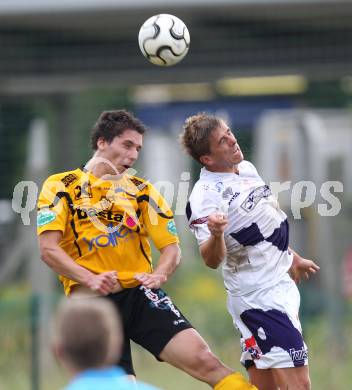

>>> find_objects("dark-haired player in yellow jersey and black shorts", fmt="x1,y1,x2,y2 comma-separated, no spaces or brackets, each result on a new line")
37,110,255,390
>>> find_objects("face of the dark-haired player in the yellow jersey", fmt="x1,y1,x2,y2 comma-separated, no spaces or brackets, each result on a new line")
98,129,143,173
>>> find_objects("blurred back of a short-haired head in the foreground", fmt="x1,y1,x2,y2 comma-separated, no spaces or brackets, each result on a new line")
52,298,122,374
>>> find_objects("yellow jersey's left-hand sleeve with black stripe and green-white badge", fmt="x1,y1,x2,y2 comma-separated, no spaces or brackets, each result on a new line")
37,176,69,235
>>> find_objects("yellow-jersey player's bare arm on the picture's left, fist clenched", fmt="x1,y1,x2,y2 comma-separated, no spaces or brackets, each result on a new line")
39,230,117,295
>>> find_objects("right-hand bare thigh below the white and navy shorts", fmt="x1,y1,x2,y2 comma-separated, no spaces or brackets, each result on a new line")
272,366,310,390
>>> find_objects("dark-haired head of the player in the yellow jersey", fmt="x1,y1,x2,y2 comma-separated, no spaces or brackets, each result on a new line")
91,110,146,172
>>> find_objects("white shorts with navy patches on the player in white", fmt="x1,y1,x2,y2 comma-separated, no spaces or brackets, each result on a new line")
227,274,308,369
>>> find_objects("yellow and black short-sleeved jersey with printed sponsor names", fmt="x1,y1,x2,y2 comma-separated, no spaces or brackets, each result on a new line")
37,168,178,295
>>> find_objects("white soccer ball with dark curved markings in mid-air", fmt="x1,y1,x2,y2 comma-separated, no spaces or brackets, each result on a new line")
138,14,190,66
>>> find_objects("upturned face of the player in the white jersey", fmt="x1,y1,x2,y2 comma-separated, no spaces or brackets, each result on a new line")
204,121,243,172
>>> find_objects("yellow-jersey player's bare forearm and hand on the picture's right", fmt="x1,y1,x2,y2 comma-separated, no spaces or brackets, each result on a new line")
135,243,181,288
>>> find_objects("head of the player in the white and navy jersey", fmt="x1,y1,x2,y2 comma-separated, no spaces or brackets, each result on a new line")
180,113,243,172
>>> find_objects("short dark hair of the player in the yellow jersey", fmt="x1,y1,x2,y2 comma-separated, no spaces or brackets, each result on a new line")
90,110,146,150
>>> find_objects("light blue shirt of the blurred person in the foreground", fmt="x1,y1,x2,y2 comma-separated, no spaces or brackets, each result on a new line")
64,367,158,390
